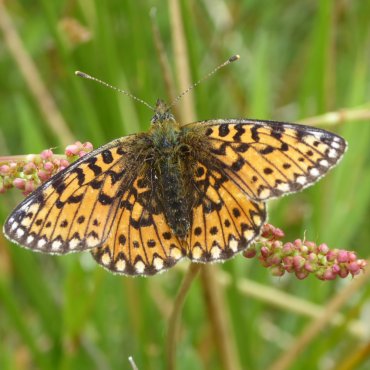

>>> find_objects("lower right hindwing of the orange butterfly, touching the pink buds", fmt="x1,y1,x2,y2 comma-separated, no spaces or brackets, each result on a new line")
187,160,266,262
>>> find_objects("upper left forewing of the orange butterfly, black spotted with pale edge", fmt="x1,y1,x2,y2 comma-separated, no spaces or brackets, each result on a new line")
4,135,135,254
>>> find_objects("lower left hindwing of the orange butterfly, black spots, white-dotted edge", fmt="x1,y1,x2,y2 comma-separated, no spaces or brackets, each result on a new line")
92,168,185,275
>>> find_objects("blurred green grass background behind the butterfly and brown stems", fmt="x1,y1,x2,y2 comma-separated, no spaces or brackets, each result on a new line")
0,0,370,370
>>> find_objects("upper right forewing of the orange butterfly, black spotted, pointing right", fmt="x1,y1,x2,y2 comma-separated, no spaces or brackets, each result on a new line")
188,119,347,200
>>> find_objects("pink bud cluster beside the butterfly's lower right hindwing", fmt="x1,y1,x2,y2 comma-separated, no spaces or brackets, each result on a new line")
244,224,366,280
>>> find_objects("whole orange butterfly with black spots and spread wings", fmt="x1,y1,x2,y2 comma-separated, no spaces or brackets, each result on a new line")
4,60,347,275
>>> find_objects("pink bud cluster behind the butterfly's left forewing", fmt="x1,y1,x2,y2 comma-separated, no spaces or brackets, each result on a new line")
0,141,93,195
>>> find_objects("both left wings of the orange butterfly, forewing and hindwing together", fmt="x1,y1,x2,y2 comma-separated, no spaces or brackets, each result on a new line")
4,135,184,275
